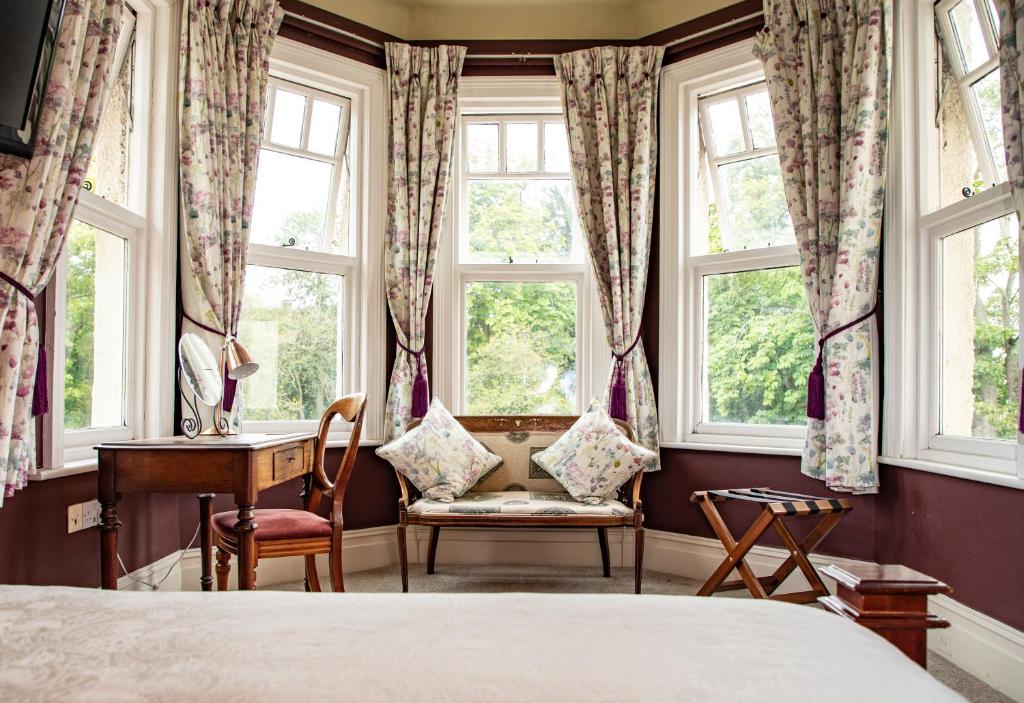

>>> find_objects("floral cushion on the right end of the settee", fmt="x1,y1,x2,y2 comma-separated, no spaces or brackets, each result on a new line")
534,398,657,504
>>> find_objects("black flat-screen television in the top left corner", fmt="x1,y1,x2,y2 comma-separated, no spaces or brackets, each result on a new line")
0,0,65,158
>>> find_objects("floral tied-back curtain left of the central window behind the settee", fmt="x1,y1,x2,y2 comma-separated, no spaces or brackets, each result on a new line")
384,43,466,440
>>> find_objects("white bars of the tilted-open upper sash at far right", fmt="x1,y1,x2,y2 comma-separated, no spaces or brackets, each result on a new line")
929,0,999,186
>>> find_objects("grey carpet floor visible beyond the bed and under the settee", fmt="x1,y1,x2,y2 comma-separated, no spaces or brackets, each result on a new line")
266,564,1013,703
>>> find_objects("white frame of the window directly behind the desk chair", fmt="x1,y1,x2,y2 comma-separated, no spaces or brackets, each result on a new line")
243,37,387,446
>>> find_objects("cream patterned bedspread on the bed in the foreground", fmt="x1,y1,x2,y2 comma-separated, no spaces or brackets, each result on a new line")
0,586,963,703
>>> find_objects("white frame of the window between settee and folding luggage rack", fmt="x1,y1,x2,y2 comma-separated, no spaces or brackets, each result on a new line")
658,40,809,455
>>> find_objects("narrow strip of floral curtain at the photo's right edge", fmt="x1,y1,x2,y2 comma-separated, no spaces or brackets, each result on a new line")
995,0,1024,432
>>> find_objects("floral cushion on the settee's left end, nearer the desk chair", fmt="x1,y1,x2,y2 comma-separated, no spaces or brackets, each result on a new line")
377,398,502,502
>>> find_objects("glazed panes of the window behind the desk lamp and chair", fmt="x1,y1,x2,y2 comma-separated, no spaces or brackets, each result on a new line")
239,78,355,423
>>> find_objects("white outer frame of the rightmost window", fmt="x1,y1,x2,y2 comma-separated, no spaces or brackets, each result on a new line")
879,0,1024,488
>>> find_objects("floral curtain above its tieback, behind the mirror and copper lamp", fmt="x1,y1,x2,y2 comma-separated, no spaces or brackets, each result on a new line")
178,0,285,422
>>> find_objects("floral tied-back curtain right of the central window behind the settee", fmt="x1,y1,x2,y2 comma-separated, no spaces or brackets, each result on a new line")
555,46,665,462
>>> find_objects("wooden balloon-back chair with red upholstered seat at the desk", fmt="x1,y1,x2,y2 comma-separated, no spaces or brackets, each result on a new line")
213,393,367,592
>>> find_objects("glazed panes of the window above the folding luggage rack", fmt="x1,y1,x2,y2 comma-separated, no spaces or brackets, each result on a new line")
690,80,815,437
